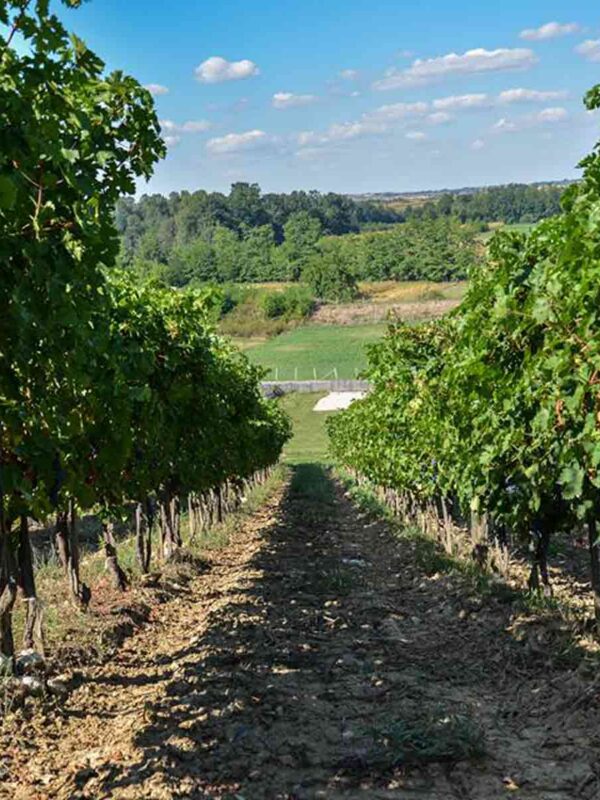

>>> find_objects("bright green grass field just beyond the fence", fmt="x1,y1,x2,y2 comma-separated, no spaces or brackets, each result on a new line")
246,323,387,380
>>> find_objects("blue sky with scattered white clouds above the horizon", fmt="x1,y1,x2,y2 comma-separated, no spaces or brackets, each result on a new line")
59,0,600,192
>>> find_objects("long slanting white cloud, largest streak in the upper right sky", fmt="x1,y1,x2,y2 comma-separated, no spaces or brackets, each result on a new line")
373,47,538,91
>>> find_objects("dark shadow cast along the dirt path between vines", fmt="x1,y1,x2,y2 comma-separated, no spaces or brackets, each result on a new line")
55,464,591,800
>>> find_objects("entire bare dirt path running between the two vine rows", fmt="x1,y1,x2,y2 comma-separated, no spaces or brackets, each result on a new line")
0,465,600,800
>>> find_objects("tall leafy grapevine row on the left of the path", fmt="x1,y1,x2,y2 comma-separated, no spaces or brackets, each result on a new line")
0,0,290,674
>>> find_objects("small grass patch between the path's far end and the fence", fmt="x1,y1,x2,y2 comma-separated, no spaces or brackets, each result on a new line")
281,392,335,464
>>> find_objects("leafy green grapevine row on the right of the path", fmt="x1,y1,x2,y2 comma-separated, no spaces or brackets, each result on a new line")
329,86,600,622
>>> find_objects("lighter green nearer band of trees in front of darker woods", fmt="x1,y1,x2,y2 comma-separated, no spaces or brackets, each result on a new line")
127,217,483,292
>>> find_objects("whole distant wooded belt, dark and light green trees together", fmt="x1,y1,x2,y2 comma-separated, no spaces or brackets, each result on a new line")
116,183,548,287
